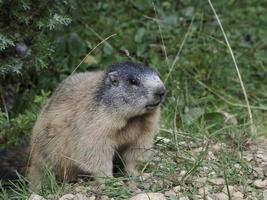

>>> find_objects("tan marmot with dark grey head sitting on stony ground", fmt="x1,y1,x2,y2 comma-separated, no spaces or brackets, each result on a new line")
0,61,166,190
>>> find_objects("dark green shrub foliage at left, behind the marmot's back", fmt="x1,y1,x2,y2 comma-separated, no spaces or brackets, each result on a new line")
0,0,72,146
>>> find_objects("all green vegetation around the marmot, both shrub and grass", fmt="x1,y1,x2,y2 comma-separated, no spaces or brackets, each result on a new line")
0,0,267,199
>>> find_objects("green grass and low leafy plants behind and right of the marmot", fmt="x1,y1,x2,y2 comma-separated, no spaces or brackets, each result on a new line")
0,0,267,199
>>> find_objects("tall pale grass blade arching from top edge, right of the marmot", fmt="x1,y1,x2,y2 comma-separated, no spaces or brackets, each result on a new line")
208,0,256,134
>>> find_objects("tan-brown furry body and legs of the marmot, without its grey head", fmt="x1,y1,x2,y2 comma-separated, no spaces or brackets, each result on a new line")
28,71,160,189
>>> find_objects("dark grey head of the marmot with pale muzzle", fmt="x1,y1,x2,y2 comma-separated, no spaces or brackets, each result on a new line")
97,62,166,117
